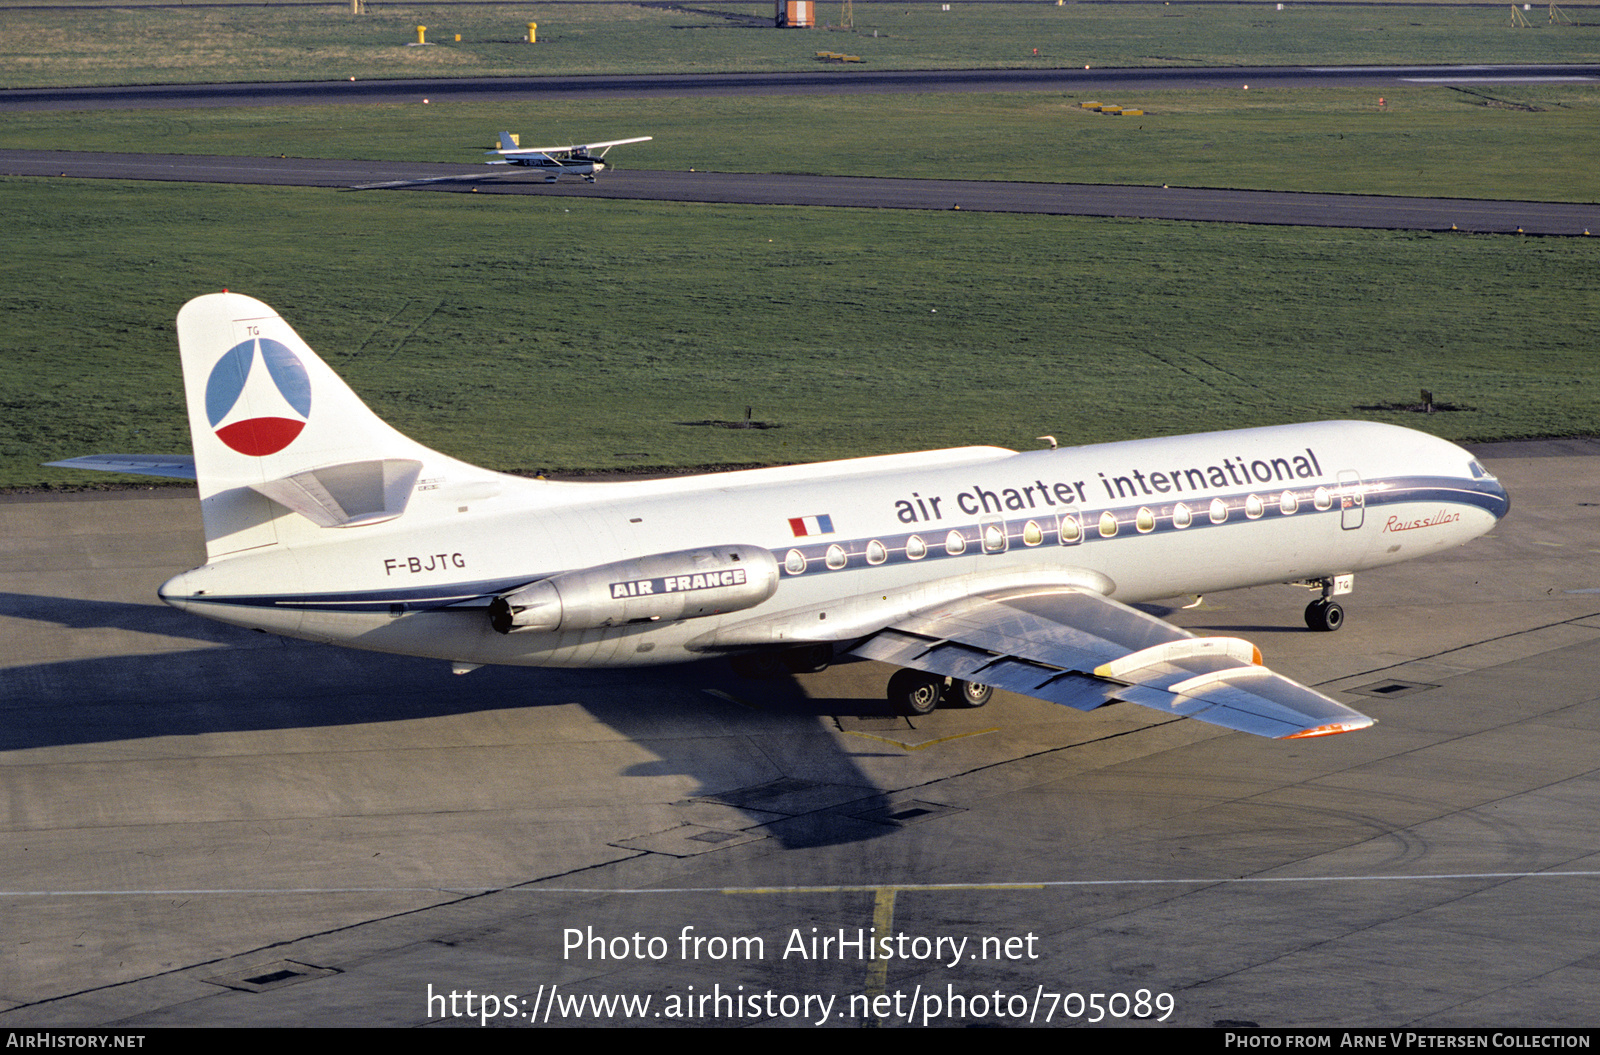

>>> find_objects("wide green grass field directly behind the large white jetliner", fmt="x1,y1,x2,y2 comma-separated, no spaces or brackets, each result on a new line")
0,179,1600,485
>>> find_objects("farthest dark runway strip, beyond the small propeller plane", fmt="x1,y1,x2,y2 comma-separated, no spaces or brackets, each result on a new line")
0,62,1600,112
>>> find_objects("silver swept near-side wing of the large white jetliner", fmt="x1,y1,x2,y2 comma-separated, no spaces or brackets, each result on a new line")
851,586,1373,738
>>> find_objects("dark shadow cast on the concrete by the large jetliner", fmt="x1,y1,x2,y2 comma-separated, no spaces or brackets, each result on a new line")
0,594,894,847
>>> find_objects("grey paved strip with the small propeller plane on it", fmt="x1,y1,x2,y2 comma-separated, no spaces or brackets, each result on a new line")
0,150,1600,235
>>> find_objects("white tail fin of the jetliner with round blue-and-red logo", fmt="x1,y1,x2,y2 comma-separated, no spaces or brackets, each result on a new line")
178,293,493,560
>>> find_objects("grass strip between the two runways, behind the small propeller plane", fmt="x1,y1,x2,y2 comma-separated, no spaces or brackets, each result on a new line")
0,85,1600,202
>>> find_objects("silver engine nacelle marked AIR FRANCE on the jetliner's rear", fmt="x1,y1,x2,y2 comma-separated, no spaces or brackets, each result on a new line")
490,546,778,634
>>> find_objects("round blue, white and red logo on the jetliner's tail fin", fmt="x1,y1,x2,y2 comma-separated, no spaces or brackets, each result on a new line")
205,338,310,458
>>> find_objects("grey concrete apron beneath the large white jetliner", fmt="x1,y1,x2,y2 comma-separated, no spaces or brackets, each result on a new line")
0,440,1600,1029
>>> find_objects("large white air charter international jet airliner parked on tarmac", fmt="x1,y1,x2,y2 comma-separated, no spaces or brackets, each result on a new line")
53,293,1509,736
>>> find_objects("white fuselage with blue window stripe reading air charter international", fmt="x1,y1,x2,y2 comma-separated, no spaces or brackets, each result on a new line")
162,421,1509,666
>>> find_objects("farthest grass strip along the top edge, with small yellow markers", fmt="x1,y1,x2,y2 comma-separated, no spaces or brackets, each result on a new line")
0,2,1600,88
